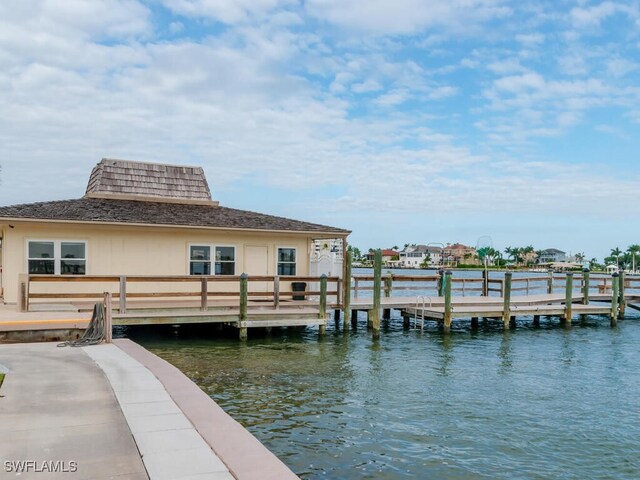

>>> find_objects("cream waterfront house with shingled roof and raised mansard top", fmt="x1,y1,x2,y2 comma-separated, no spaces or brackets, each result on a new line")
0,158,350,303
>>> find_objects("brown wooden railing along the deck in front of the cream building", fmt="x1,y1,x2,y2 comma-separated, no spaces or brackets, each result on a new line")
20,275,341,313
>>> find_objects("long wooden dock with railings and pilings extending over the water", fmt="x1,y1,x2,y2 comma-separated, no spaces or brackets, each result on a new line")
6,251,640,339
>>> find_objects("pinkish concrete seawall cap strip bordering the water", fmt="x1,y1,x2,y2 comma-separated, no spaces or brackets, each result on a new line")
113,339,298,480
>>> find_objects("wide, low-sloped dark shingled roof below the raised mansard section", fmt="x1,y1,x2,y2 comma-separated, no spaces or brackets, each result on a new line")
0,197,351,237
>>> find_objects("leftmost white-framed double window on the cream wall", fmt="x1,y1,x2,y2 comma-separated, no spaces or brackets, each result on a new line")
27,240,87,275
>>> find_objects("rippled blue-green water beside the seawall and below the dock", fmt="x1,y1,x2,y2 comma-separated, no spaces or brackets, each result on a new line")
128,270,640,479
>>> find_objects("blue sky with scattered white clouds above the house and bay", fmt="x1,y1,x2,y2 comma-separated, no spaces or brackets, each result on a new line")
0,0,640,258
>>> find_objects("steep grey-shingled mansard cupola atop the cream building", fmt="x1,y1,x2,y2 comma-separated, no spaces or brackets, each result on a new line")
85,158,216,205
